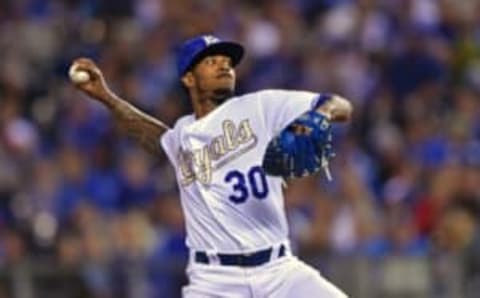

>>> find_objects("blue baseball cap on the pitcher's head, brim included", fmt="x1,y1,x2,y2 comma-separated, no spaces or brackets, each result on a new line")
177,35,244,77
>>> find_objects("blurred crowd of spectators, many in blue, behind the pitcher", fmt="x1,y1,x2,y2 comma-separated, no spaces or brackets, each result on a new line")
0,0,480,297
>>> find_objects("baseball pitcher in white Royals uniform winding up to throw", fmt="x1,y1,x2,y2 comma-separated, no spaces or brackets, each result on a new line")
70,35,352,298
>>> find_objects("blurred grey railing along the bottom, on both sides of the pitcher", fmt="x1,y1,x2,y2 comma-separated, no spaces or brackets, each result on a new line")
0,256,464,298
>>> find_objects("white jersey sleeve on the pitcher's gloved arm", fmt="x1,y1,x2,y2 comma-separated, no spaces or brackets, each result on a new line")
259,90,318,137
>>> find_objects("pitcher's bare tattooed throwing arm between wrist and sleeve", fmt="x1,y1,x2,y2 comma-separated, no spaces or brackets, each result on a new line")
103,94,168,155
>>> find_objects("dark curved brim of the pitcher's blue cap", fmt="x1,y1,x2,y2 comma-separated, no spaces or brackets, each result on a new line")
183,41,245,74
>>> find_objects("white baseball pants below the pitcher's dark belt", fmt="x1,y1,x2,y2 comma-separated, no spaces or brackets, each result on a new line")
183,255,347,298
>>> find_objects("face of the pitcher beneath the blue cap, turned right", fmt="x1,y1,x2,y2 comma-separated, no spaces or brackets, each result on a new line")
187,55,235,101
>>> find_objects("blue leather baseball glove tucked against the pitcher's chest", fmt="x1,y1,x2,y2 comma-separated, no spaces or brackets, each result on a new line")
262,110,335,180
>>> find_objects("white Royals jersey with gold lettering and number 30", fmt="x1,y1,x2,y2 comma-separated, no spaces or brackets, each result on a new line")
161,90,317,253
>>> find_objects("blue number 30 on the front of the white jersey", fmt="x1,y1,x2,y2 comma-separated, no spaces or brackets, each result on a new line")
224,166,268,204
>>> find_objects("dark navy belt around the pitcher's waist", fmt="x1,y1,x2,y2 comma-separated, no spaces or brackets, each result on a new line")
195,244,285,267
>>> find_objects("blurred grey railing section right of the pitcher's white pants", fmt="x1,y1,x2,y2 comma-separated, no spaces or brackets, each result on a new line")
307,256,465,298
